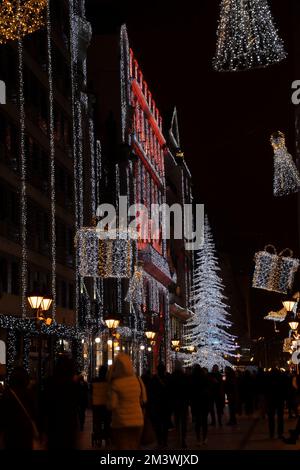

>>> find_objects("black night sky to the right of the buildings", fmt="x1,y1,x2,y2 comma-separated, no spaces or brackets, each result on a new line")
87,0,300,344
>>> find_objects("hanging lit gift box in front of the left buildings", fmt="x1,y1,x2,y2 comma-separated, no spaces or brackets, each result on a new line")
75,227,137,278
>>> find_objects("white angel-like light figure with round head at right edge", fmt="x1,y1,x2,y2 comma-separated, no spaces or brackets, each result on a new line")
270,131,300,196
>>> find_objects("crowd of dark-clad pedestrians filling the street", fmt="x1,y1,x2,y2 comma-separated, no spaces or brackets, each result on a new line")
0,353,300,450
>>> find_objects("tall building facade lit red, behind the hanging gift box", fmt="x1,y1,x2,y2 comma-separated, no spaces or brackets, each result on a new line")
89,26,172,372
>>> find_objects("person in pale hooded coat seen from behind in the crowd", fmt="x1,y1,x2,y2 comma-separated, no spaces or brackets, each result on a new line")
108,353,147,450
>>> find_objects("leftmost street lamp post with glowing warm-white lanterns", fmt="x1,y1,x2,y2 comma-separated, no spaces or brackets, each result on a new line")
27,293,53,390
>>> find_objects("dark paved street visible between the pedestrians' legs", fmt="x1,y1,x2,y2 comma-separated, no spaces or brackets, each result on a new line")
78,410,300,450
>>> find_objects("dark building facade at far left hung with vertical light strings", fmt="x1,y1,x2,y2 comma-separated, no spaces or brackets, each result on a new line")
0,0,97,375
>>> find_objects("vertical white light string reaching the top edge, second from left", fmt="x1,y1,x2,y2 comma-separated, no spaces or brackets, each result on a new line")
47,1,56,319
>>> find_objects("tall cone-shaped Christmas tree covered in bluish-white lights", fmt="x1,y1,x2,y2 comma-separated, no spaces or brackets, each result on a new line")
186,217,236,369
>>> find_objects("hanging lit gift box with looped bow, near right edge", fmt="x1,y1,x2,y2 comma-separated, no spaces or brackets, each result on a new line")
252,245,299,294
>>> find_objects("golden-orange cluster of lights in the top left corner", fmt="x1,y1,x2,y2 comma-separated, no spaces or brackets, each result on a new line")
0,0,48,44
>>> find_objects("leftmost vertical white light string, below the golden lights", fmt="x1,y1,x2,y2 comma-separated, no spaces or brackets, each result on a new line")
18,39,28,317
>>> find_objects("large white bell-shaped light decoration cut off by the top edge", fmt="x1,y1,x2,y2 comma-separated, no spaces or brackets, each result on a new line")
213,0,287,72
